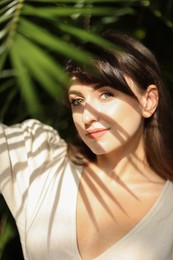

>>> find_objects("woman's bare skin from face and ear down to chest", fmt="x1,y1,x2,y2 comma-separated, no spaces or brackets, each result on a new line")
69,78,165,260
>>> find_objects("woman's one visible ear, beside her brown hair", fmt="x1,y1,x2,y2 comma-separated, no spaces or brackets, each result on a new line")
142,85,159,118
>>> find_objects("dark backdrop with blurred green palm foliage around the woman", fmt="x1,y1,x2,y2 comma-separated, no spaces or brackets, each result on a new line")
0,0,173,260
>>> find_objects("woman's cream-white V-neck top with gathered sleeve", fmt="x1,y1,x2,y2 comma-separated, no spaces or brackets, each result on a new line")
0,120,173,260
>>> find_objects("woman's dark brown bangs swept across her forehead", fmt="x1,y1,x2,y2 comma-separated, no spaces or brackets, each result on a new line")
66,44,135,97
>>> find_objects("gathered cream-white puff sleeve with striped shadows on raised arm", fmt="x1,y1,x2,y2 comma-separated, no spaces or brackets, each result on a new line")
0,120,67,219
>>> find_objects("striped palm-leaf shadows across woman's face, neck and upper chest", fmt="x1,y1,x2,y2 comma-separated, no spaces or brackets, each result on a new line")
71,97,159,230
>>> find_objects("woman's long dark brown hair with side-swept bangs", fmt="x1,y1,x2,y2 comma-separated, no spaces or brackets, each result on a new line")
66,32,173,180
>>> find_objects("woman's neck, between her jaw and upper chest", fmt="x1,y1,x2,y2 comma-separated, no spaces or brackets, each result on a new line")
88,135,162,182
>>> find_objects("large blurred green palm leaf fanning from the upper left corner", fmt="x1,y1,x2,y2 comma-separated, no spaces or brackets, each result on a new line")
0,0,172,119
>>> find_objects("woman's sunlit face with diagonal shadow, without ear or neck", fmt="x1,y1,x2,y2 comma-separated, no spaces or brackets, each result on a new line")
69,79,143,155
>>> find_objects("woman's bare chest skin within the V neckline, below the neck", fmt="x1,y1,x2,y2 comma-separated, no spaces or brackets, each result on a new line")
77,179,168,260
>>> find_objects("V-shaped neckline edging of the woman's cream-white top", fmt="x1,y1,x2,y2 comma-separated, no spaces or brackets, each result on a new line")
74,167,170,260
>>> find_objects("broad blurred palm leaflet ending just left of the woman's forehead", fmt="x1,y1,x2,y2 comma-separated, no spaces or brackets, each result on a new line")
13,36,67,100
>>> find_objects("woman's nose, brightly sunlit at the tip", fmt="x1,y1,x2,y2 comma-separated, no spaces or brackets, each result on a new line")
82,103,98,124
